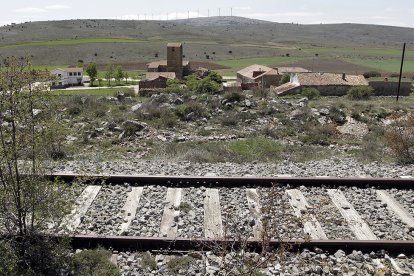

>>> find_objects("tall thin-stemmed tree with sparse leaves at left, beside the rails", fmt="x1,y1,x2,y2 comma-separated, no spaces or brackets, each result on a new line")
0,57,68,275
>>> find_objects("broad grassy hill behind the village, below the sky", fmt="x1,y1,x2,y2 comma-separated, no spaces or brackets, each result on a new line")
0,17,414,72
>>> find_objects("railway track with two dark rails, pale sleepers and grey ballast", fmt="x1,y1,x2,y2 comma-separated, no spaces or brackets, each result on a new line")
50,174,414,275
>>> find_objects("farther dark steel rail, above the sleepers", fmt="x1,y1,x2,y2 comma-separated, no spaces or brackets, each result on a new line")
45,174,414,189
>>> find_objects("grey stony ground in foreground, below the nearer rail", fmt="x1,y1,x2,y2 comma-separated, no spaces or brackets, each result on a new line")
110,248,414,276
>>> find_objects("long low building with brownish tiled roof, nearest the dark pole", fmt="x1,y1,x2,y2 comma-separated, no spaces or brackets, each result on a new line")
272,73,368,96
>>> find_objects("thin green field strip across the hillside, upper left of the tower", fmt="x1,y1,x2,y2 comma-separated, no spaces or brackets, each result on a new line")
0,38,145,48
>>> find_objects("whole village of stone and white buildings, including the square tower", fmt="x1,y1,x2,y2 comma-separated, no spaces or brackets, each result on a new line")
51,43,411,96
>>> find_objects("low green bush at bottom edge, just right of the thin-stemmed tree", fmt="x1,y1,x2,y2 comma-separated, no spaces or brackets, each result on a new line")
72,248,121,276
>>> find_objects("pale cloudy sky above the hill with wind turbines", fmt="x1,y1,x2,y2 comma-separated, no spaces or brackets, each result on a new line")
0,0,414,28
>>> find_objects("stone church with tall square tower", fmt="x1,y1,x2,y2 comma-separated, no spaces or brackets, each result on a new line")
147,43,190,79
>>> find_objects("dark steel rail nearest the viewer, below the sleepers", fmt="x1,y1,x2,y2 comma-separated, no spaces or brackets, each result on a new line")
71,235,414,255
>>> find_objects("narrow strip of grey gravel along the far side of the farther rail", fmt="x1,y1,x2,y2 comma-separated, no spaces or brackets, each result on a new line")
49,158,414,177
